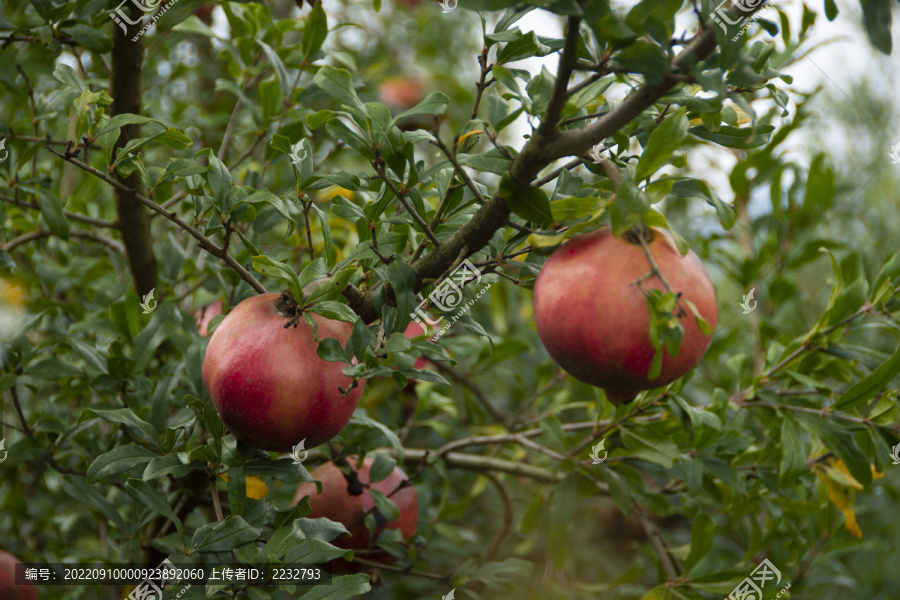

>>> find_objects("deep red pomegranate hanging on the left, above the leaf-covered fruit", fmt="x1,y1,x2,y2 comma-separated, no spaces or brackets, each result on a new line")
203,291,365,452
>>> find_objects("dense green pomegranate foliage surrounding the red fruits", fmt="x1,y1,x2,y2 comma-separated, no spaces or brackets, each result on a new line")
0,0,900,600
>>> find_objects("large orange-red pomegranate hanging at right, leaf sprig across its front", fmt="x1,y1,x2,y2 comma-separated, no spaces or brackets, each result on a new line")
534,228,718,405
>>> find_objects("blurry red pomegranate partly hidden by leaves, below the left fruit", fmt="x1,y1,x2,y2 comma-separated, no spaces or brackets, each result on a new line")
294,456,419,550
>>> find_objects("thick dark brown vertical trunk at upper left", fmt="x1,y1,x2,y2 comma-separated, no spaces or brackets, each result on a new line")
109,6,157,295
